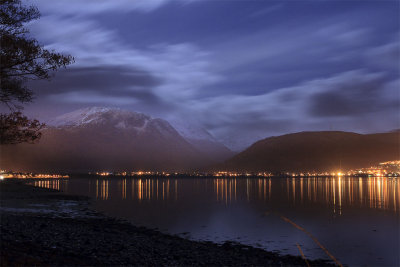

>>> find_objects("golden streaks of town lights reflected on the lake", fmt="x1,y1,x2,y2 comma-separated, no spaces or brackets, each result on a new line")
34,177,400,214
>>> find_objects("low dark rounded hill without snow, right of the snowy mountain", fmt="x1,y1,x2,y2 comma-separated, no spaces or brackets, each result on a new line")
217,131,400,172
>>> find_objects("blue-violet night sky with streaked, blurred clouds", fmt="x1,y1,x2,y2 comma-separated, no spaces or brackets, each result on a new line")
25,0,400,151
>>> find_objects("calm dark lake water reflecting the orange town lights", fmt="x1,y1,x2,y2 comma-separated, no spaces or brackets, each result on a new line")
35,177,400,266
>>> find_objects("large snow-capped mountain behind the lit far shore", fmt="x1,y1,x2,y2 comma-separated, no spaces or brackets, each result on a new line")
0,107,231,172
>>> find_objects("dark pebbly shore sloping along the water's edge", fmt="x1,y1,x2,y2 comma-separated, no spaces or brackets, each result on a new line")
0,180,332,266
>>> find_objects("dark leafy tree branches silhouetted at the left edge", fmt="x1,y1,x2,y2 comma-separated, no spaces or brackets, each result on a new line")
0,0,74,144
